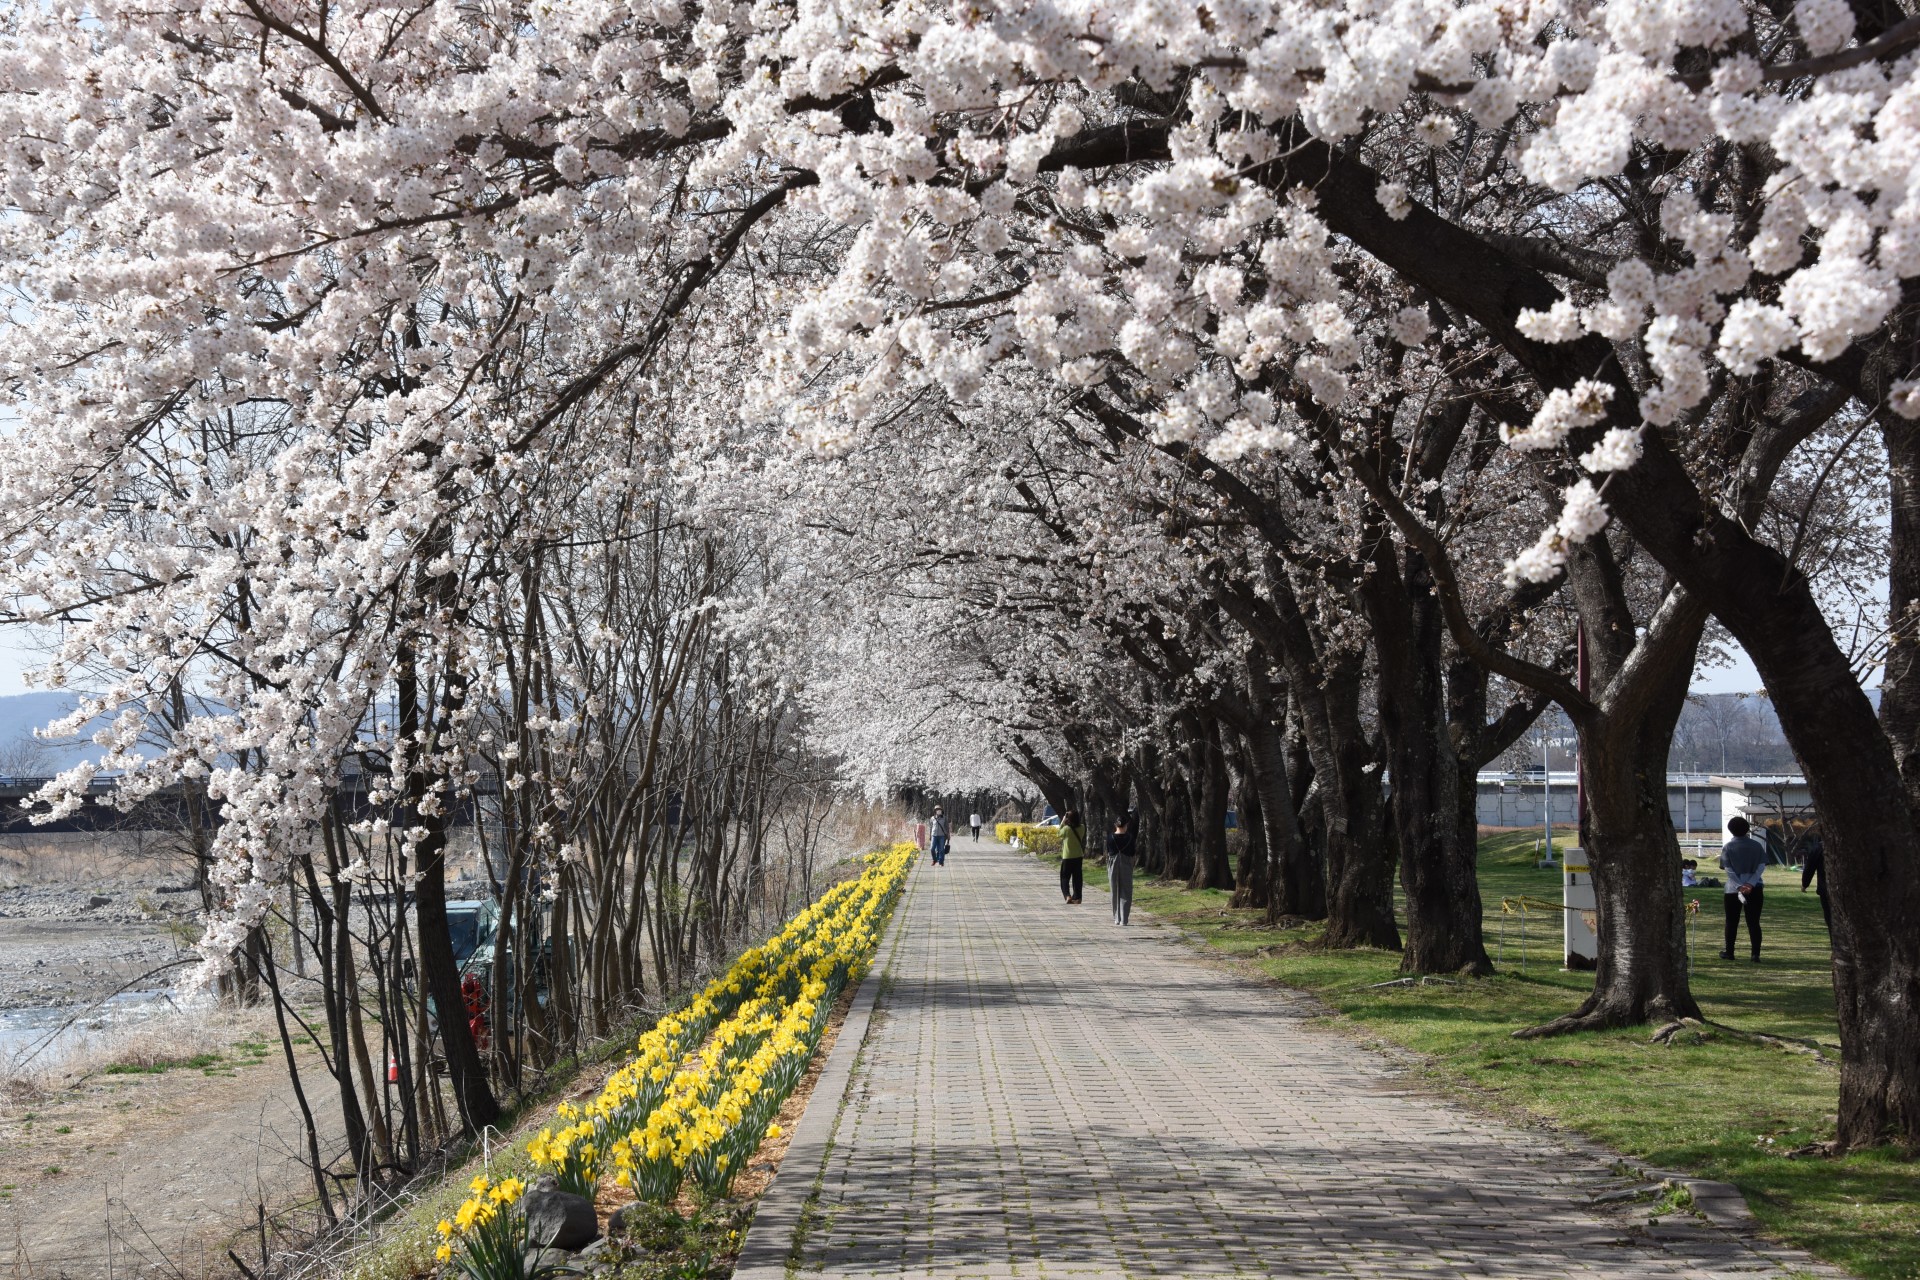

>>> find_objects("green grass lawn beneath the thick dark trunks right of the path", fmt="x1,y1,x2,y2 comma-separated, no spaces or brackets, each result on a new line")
1036,833,1920,1280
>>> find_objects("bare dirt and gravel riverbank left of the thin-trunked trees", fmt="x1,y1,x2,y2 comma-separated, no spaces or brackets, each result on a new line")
0,837,344,1280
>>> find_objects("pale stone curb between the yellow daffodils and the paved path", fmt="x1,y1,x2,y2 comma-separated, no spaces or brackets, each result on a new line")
733,862,920,1280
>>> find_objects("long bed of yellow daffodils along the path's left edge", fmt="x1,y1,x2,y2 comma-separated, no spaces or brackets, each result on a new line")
440,842,918,1280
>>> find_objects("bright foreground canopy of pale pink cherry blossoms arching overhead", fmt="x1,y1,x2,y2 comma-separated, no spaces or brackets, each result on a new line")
0,0,1920,969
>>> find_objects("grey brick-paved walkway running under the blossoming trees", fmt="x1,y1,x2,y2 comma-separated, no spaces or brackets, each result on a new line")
756,839,1837,1278
